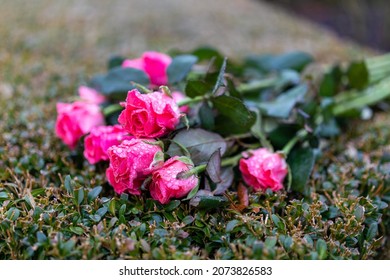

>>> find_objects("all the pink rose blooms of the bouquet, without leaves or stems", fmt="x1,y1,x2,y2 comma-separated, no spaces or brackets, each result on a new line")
55,52,288,204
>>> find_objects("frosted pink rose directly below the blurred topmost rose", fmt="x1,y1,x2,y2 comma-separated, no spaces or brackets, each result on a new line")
118,89,180,138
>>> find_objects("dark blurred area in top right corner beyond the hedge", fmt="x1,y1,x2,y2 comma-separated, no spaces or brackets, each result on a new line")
266,0,390,51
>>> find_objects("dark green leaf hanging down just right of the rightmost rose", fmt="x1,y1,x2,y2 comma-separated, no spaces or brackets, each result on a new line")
287,148,315,196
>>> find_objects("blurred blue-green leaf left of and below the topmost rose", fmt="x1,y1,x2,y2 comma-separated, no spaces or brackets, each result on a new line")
91,67,150,100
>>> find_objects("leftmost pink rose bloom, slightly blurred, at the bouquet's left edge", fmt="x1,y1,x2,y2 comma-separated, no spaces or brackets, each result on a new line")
55,101,104,149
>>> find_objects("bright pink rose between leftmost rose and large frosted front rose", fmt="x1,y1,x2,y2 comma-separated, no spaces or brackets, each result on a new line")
84,125,133,164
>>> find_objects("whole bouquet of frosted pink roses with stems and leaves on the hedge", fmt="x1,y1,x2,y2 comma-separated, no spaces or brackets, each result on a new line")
55,48,390,207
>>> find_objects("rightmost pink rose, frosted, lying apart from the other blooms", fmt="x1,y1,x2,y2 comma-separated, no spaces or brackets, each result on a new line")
239,148,288,191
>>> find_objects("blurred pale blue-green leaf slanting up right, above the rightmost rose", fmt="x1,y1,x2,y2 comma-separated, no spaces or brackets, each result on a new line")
259,84,308,118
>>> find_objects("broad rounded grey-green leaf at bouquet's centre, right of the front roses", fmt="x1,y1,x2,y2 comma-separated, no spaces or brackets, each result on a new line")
167,128,227,165
